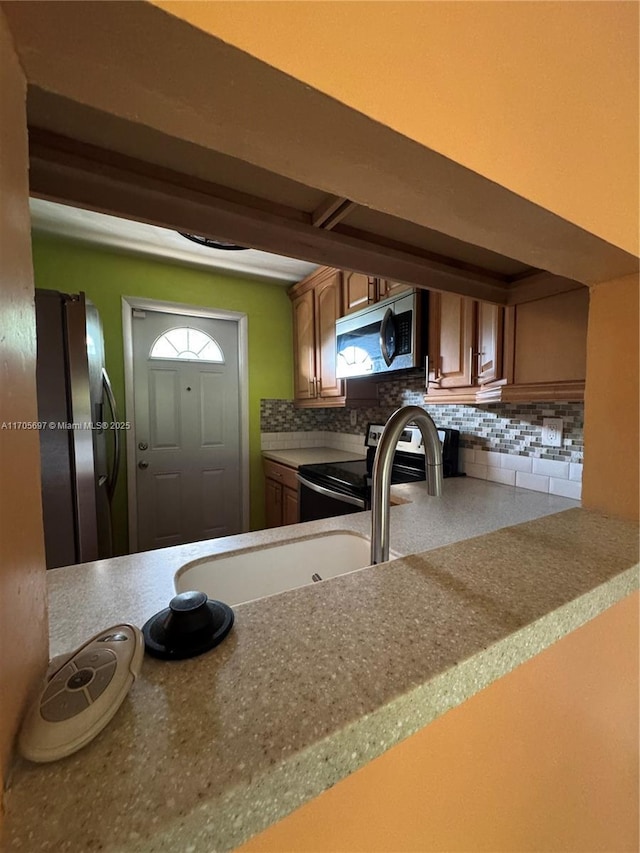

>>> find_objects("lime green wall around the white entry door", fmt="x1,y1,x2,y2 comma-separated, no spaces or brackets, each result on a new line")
33,234,293,554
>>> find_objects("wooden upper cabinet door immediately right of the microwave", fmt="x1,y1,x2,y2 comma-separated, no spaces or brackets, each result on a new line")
429,293,475,388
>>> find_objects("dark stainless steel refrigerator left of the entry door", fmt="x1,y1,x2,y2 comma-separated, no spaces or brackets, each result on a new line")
36,290,120,569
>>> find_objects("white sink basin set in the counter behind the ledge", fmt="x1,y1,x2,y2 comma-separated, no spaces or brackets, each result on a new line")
175,531,395,605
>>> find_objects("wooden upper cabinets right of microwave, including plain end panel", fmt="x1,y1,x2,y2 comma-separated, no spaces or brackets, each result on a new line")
425,282,589,403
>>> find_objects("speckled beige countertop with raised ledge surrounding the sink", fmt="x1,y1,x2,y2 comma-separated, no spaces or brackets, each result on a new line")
6,480,638,853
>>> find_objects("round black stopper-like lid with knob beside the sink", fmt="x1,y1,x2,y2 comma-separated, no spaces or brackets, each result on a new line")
142,590,234,660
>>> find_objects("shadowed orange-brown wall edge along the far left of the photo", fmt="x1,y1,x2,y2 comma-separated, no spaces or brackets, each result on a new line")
0,11,48,792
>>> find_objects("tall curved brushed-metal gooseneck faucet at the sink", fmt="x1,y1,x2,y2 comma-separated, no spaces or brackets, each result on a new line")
371,406,442,565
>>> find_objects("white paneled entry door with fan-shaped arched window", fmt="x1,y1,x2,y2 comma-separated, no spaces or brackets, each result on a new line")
132,310,242,551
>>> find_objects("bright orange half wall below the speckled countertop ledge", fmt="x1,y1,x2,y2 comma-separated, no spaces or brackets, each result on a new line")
238,593,640,853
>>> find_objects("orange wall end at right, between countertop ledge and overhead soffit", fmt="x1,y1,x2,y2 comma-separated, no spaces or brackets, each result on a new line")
582,276,640,519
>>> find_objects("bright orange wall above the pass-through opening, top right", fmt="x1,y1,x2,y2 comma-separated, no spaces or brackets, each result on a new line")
156,0,640,254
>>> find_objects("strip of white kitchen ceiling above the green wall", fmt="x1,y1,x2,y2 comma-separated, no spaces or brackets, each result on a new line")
29,198,317,285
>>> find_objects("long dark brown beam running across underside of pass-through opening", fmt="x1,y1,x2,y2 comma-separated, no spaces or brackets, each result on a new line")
30,130,508,304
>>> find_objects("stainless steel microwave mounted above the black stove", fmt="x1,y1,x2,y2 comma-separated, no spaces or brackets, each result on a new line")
336,290,429,379
